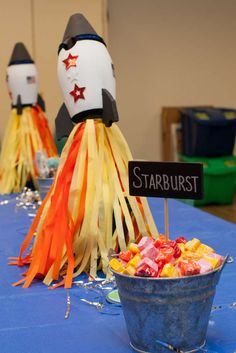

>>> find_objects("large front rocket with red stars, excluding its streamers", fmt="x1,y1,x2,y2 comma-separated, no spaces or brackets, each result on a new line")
56,14,118,138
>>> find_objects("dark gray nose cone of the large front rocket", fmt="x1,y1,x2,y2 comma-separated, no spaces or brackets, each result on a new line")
63,13,97,42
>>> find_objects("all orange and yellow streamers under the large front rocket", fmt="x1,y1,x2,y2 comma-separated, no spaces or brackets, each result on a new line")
12,119,158,288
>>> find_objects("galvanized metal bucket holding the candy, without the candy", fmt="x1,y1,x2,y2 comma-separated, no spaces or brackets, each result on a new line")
113,265,226,353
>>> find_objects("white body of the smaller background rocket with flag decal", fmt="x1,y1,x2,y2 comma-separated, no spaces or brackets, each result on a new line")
7,63,38,106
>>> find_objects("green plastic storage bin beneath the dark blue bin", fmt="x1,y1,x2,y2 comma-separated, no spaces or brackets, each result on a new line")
180,155,236,206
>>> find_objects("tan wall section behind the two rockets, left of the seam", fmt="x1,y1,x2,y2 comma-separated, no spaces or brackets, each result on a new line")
0,0,107,141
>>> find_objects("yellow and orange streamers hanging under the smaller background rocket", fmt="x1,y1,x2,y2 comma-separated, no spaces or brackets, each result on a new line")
0,105,57,194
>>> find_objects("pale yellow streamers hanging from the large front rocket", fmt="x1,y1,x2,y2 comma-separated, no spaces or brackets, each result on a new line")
14,119,158,285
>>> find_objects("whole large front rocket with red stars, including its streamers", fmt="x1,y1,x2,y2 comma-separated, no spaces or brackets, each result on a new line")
13,14,158,288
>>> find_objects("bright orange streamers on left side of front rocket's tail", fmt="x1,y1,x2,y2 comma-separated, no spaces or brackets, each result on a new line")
17,124,84,288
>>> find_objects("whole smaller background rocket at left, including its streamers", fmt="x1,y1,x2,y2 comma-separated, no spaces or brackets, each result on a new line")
0,43,57,194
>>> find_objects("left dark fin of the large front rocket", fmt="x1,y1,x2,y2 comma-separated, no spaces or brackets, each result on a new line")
55,103,74,140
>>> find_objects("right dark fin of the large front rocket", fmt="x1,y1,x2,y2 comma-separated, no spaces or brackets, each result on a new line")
102,88,119,127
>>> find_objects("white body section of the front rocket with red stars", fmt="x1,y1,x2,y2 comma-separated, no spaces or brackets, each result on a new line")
57,39,116,118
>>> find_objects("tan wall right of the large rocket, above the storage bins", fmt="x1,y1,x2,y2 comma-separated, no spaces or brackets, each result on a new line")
108,0,236,160
